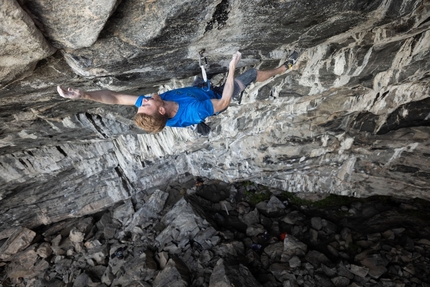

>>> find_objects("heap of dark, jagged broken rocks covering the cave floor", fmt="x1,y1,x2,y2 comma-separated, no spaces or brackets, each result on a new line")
0,178,430,287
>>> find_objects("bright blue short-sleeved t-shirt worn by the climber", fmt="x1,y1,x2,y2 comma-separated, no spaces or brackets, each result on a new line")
136,87,221,127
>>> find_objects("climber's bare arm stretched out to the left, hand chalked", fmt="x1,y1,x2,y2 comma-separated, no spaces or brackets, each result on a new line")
57,86,138,106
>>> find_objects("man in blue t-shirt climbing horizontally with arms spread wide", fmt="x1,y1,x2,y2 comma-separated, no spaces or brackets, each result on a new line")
57,52,298,133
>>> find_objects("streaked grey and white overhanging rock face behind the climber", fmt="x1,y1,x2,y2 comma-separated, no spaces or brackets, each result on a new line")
0,0,430,258
